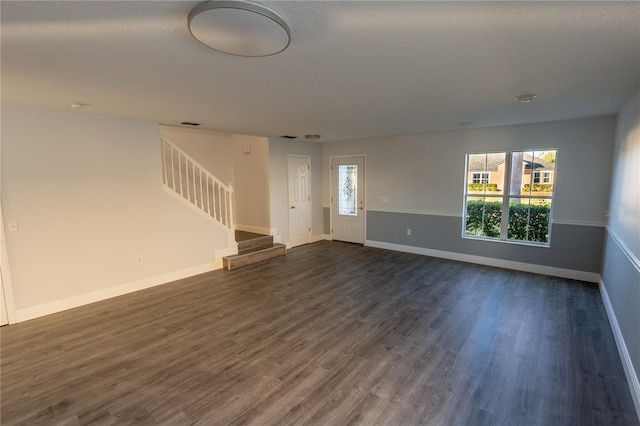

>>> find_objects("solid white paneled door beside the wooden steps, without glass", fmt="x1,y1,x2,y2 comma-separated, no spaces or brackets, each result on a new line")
288,155,311,247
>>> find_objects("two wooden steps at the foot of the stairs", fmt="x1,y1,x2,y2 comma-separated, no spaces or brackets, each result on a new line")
222,231,287,270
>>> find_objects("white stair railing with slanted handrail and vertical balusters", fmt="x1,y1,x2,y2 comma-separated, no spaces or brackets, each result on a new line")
161,137,234,231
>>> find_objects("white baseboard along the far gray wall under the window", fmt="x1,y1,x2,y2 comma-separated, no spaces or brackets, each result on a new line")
364,240,601,283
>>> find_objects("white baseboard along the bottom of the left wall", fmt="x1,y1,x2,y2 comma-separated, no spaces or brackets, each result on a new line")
15,263,215,322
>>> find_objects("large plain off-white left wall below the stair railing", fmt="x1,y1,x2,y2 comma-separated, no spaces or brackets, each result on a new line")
2,104,227,319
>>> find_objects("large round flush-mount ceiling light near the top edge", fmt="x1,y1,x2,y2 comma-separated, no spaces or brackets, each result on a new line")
187,0,291,57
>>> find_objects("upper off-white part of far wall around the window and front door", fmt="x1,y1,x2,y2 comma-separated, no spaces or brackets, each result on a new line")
323,117,615,224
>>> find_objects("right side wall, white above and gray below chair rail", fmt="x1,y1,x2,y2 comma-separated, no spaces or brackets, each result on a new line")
602,92,640,398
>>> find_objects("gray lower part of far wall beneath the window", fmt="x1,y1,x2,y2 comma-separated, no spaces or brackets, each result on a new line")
367,210,604,273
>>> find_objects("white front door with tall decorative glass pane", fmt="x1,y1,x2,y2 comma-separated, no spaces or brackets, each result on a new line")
331,156,365,244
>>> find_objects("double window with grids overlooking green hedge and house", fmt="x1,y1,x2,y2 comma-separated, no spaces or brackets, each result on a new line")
463,150,557,246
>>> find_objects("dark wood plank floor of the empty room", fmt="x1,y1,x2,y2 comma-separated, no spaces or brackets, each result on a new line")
1,241,638,426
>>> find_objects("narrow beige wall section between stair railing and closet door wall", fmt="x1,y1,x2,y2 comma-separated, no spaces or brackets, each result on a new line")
233,135,271,231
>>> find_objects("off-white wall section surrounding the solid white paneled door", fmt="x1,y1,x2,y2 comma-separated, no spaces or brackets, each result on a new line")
269,138,324,243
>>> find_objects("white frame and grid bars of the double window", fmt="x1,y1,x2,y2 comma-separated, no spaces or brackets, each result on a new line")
462,148,558,248
